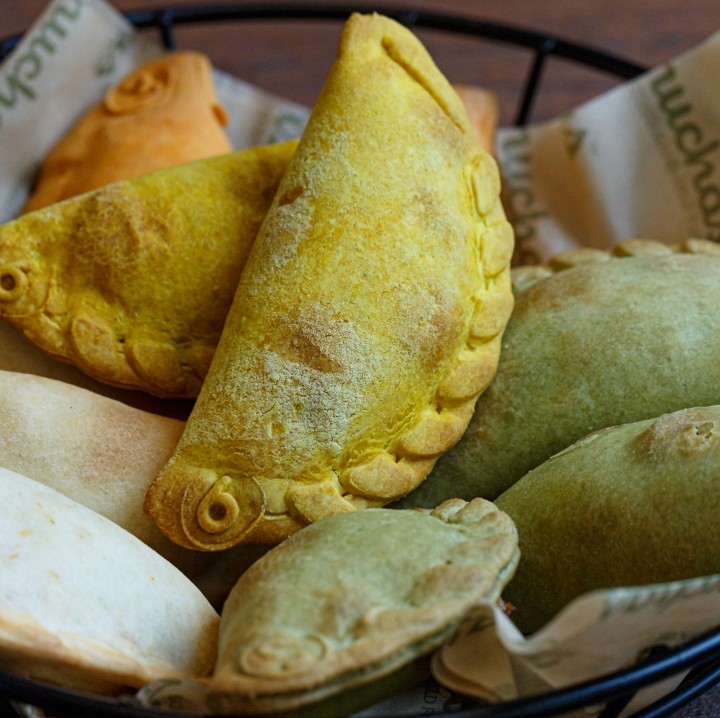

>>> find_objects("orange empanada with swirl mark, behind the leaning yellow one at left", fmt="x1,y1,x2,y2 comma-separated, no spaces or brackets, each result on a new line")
23,50,232,212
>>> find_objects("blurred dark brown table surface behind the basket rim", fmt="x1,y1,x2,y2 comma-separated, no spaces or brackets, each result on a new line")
0,0,720,124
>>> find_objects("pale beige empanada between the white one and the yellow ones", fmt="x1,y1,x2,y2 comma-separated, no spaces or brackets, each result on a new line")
0,370,262,608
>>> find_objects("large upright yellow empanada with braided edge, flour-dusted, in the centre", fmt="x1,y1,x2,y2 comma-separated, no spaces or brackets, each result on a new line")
146,14,513,550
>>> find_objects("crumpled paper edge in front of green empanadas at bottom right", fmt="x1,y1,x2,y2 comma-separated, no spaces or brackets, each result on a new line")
433,575,720,718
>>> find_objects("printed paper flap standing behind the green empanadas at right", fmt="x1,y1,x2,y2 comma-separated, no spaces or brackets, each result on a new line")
496,33,720,264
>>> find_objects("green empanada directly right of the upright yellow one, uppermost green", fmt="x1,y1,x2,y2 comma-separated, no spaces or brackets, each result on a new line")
399,240,720,508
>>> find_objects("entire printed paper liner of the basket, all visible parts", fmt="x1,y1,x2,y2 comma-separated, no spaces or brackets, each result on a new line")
0,0,720,718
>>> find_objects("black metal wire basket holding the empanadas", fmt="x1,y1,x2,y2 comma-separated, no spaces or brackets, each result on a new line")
0,3,720,718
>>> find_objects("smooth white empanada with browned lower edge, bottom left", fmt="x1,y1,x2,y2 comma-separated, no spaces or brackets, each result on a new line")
0,468,219,694
